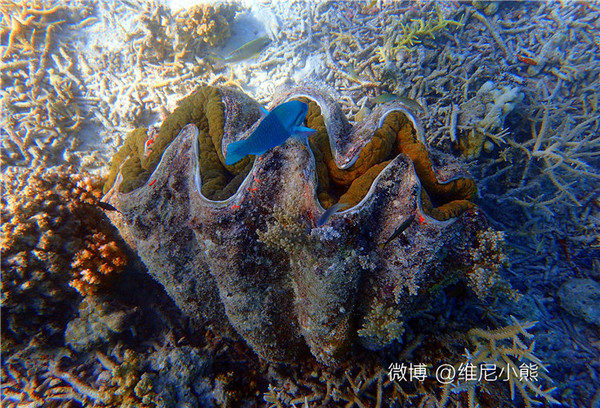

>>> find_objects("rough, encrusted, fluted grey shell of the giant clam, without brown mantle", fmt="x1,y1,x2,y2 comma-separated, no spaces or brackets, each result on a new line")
105,89,488,364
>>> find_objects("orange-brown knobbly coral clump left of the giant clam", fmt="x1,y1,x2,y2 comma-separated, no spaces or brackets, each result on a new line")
0,166,125,340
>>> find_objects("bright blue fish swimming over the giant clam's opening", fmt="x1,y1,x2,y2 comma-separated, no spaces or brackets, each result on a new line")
225,101,316,165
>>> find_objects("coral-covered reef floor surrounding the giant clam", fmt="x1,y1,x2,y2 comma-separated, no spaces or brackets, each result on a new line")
0,0,600,407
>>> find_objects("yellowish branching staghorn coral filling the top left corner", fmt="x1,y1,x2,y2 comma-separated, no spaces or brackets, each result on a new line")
0,0,87,166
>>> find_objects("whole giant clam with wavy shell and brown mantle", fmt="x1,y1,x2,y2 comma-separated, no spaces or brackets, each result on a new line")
104,87,484,364
